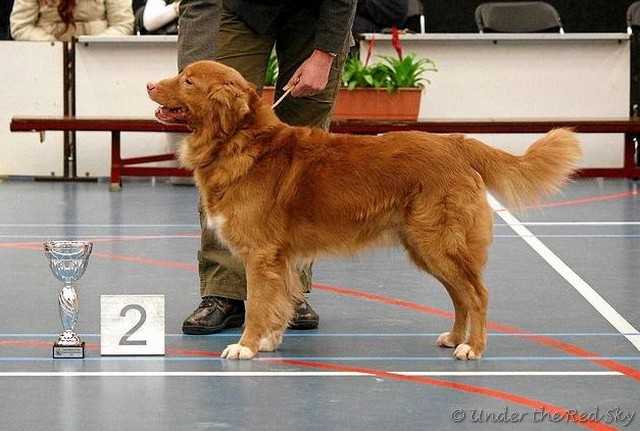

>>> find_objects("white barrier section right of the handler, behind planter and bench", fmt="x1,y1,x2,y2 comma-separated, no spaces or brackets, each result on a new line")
361,34,630,167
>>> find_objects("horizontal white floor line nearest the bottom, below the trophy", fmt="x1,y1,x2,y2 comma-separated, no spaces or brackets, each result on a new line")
0,371,623,377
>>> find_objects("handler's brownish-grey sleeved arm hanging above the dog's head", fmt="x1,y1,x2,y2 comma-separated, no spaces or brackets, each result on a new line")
178,0,222,70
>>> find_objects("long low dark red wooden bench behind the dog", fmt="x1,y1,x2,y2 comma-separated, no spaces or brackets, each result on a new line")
11,117,640,190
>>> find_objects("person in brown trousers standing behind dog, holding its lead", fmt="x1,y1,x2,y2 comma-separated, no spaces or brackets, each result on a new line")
178,0,356,334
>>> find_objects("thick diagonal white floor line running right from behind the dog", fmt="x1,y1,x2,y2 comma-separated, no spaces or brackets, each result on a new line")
488,195,640,351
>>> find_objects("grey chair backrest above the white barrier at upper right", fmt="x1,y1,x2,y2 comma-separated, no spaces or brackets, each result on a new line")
476,1,564,33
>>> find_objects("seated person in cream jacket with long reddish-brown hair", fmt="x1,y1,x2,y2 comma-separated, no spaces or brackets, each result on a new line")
11,0,133,41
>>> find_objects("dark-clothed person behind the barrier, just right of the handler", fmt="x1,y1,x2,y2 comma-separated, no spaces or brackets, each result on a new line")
353,0,409,34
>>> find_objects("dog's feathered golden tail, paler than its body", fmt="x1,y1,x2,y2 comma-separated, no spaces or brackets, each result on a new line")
462,129,582,209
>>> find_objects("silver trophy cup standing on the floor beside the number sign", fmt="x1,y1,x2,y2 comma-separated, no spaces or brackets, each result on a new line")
44,241,93,359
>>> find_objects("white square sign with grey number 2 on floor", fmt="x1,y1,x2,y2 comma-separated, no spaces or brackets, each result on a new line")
100,295,164,355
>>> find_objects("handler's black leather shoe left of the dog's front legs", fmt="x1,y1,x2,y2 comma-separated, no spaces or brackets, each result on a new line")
182,296,244,335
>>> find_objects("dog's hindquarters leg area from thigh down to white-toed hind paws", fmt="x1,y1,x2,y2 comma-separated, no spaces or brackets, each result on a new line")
401,189,492,359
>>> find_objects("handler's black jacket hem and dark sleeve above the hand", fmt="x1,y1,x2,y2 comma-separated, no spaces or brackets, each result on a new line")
224,0,356,53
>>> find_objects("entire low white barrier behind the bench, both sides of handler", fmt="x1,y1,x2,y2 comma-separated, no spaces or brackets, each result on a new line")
0,34,630,176
